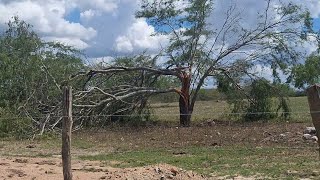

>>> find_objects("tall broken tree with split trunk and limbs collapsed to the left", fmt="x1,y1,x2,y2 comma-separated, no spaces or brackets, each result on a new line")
73,0,318,126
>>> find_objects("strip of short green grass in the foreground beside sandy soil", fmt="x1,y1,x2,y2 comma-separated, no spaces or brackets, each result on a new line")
80,147,319,179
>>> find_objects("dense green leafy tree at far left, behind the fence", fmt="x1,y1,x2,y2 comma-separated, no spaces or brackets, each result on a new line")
0,17,83,133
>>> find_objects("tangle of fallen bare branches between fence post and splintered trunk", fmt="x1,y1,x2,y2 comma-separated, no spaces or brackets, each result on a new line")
69,55,179,125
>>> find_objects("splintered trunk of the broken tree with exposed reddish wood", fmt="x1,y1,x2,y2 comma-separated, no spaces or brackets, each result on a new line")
179,71,192,127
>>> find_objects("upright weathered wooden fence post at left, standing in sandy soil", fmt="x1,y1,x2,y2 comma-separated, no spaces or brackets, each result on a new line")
61,86,72,180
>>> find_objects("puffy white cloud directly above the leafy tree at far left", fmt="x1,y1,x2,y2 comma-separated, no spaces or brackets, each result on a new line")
0,0,97,49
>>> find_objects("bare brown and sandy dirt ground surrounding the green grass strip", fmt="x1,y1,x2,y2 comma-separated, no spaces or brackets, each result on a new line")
0,121,317,180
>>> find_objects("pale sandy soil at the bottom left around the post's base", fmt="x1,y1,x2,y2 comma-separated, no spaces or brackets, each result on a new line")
0,157,212,180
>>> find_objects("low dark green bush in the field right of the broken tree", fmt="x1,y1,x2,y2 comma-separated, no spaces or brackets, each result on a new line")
218,78,293,121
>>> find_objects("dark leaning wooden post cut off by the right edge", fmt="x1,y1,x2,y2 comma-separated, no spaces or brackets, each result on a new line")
307,85,320,157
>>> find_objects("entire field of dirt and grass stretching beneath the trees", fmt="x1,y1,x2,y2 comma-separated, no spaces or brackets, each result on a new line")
0,97,320,179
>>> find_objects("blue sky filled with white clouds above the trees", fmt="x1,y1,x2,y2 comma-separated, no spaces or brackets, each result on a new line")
0,0,320,59
